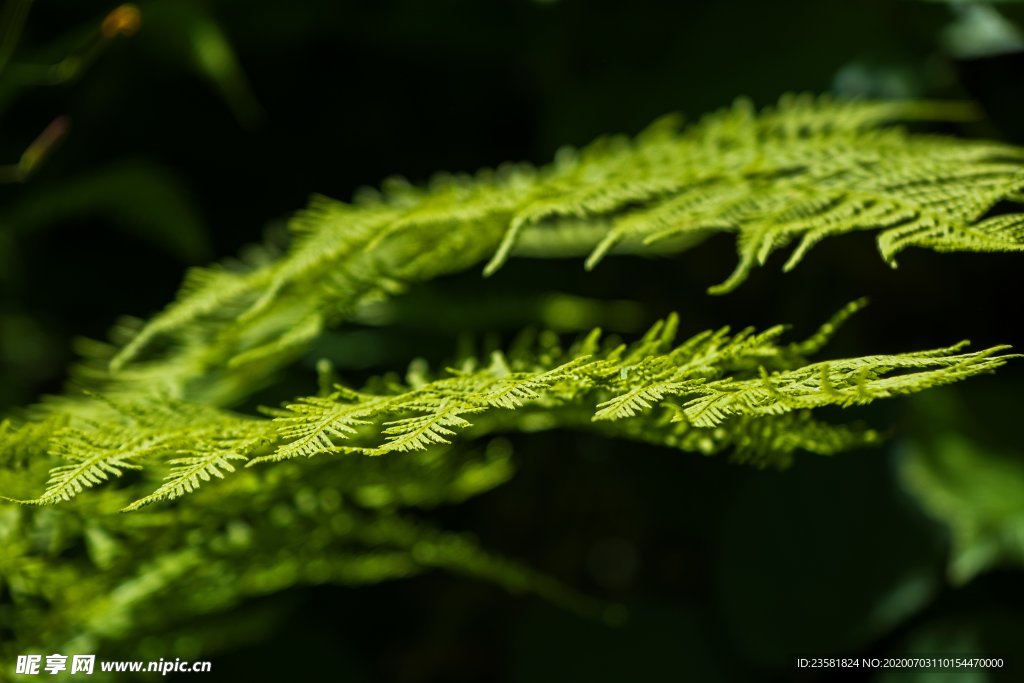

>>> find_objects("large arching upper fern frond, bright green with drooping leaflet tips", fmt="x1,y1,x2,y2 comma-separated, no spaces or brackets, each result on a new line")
81,96,1024,411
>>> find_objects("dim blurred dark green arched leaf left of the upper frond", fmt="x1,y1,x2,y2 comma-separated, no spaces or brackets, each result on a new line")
0,161,211,263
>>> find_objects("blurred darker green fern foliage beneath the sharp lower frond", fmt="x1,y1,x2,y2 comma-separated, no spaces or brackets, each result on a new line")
0,442,605,680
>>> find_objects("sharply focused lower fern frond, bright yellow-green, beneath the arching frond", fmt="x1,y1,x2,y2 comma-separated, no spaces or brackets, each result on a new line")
16,301,1012,509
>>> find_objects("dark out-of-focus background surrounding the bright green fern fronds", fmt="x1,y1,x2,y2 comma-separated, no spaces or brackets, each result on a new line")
6,0,1024,683
